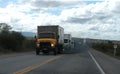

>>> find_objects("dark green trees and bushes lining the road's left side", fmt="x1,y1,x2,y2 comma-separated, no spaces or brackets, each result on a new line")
0,23,35,53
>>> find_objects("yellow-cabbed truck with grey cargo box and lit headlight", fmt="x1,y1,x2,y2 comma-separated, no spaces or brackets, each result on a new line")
36,25,64,55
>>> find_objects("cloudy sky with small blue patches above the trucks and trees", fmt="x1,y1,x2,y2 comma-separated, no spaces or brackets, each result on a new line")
0,0,120,40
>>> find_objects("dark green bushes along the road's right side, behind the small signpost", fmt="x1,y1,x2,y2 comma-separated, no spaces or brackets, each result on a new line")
92,41,120,59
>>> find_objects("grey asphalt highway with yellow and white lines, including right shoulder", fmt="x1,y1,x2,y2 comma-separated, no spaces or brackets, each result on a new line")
0,44,120,74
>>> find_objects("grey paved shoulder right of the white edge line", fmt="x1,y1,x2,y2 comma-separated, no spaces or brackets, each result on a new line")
90,50,120,74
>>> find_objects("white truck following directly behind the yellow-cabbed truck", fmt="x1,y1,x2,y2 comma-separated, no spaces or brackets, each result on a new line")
64,34,72,50
